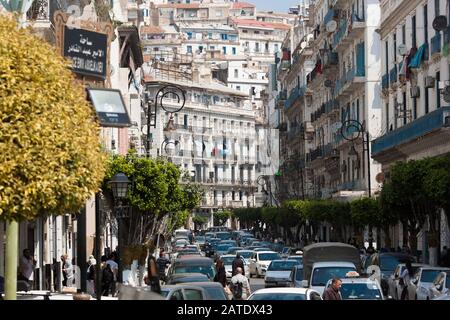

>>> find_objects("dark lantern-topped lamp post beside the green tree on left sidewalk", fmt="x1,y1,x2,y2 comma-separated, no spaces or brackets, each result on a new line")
109,172,131,282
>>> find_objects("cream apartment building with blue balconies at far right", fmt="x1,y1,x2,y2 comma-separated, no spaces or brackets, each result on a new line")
371,0,450,252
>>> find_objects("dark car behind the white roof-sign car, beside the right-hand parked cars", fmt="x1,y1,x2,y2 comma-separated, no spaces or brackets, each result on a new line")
364,252,417,296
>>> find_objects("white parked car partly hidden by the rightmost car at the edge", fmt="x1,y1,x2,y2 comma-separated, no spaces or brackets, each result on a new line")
408,266,450,300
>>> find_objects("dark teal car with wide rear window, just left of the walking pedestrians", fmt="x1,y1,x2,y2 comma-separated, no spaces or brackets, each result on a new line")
168,256,216,279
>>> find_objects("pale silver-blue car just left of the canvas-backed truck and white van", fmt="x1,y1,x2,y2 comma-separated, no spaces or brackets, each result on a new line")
264,259,300,288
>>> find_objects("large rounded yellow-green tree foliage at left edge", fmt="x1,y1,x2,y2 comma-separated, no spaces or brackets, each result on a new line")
0,15,106,220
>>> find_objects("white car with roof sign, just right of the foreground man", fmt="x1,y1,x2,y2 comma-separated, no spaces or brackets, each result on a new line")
326,277,384,300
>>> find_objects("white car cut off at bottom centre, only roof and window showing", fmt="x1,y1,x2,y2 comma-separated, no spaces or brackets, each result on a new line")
248,288,322,301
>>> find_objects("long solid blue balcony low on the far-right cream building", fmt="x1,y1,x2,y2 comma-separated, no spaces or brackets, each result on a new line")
372,107,450,159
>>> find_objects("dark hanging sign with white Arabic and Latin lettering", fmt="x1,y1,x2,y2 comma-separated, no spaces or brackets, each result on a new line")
64,27,108,79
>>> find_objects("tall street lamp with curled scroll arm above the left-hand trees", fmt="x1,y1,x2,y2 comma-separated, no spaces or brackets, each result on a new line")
147,85,186,158
